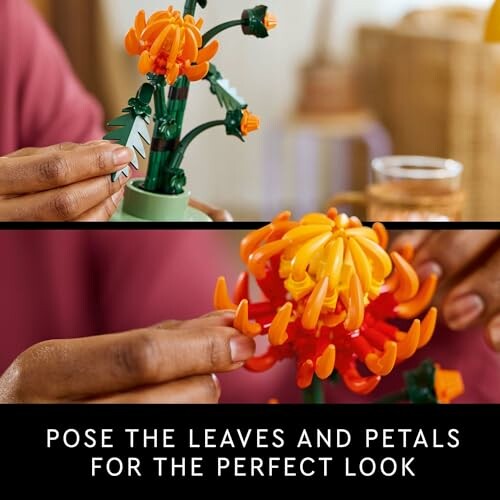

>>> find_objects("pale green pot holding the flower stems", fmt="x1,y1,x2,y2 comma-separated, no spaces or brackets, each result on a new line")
111,179,213,222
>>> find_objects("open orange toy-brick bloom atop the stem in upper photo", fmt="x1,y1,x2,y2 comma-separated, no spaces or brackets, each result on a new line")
125,6,219,85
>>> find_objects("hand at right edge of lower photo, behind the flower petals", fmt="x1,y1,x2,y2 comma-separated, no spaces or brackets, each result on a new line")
394,230,500,352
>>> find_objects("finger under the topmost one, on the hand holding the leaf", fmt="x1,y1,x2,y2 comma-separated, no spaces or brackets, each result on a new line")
0,170,128,221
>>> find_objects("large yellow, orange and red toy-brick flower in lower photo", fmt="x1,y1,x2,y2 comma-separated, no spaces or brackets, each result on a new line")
214,209,437,394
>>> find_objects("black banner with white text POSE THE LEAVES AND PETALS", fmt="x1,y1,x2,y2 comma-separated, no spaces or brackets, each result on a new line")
0,405,500,492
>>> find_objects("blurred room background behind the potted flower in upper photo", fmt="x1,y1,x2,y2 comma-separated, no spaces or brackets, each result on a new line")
32,0,500,220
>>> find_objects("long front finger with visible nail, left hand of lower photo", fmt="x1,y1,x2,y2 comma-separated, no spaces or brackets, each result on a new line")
12,325,255,401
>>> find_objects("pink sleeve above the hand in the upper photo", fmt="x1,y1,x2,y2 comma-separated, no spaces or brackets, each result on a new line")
0,0,103,156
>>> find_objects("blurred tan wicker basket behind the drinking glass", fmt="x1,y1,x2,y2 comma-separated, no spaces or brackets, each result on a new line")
359,9,500,220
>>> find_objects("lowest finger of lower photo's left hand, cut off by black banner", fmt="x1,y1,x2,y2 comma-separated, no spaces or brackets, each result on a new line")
89,375,221,404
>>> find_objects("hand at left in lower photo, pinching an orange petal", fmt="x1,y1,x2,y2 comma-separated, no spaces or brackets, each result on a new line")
0,312,255,403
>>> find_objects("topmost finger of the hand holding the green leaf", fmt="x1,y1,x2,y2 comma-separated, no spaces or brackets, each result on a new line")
0,142,133,195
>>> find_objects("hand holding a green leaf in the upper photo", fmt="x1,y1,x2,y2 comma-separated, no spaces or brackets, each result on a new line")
0,141,133,222
